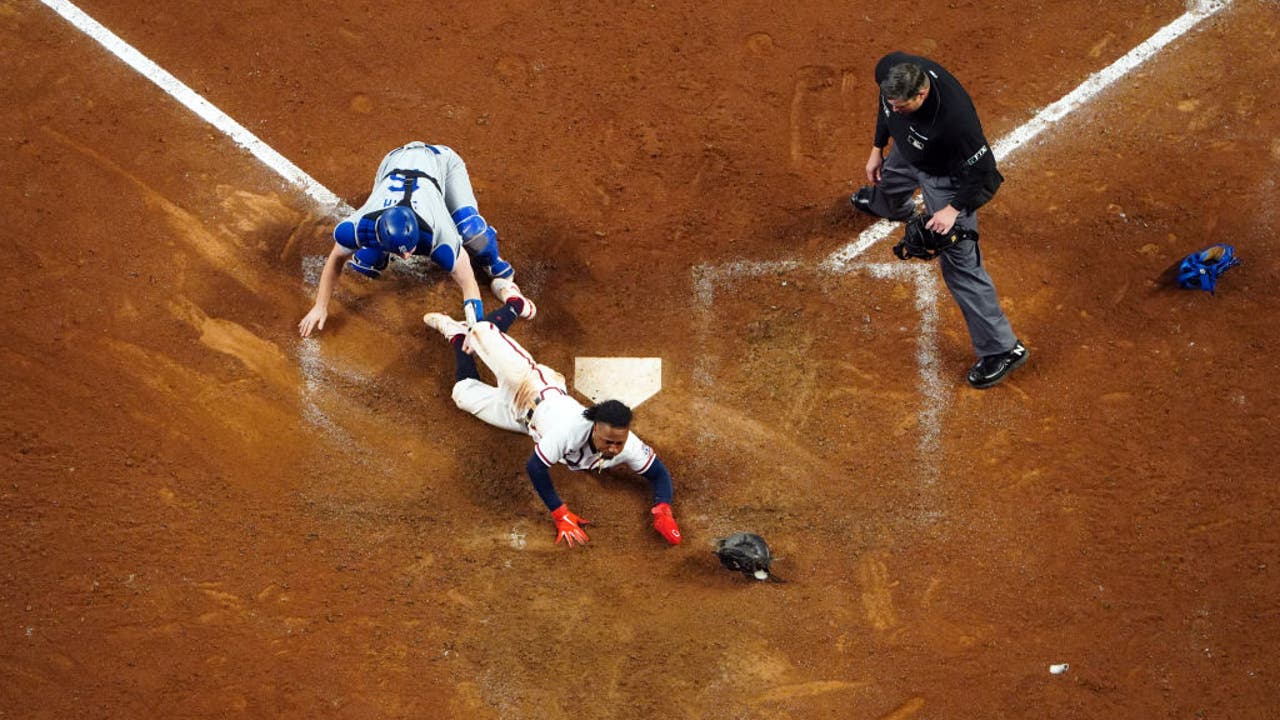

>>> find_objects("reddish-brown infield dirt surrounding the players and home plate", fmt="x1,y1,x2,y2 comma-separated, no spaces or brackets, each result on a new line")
0,0,1280,720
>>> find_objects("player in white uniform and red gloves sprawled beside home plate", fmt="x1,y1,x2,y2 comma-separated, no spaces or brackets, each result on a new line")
422,297,682,547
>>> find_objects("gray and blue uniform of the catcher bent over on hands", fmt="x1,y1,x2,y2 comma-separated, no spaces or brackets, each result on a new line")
333,142,515,278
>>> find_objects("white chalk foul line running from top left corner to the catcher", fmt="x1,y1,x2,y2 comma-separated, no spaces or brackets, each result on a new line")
40,0,352,214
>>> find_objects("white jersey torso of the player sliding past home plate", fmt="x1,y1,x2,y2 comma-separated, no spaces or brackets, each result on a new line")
529,395,657,474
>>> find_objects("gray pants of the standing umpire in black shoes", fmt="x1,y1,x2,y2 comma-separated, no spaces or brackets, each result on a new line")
870,147,1018,357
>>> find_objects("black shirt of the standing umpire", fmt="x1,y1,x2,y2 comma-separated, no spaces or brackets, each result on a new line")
876,53,1004,211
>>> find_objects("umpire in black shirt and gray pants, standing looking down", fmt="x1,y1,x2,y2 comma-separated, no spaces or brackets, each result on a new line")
849,53,1029,388
